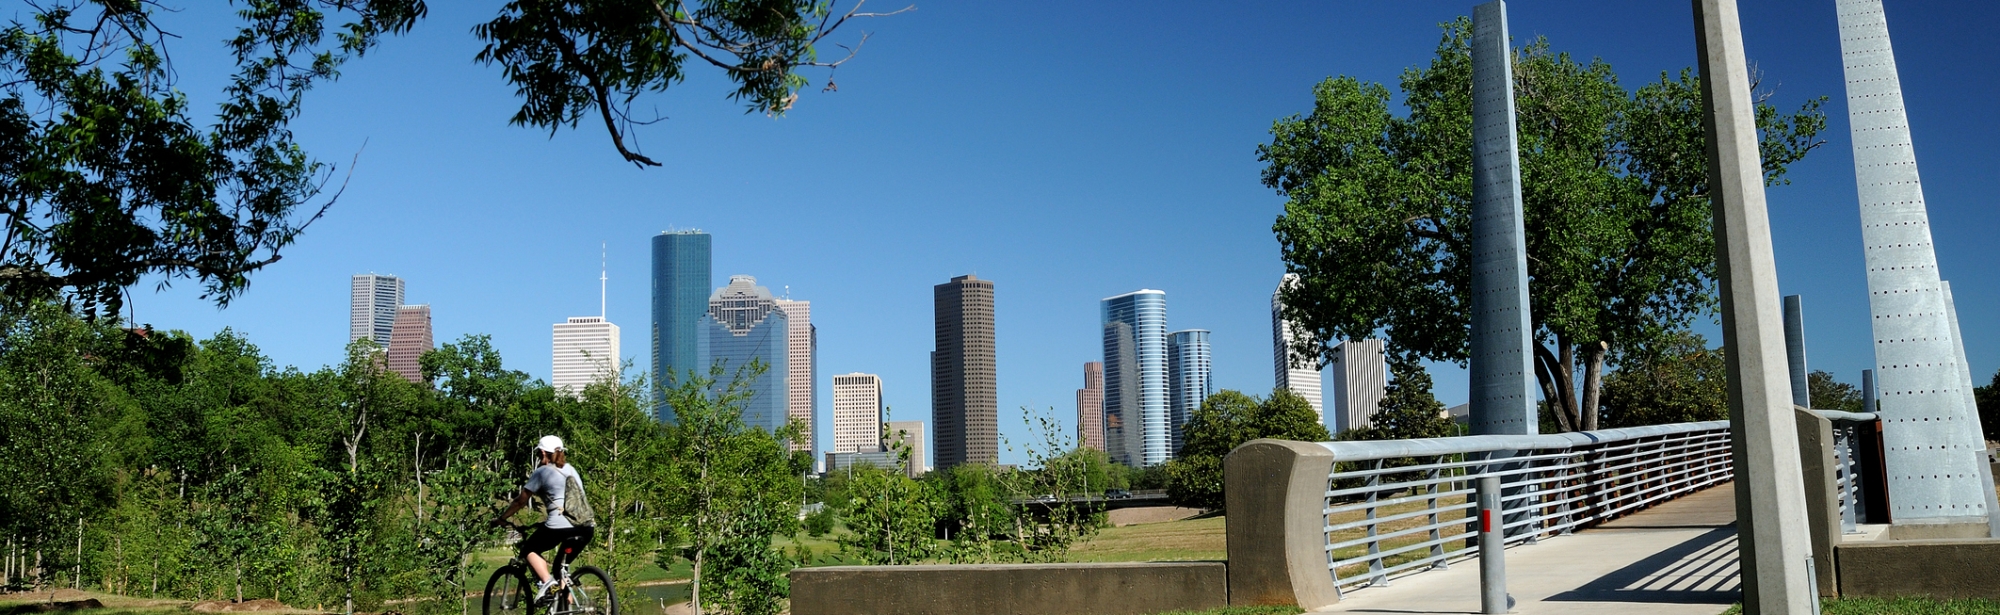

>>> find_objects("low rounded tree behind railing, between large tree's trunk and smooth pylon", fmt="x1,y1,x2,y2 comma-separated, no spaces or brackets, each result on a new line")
1604,331,1730,427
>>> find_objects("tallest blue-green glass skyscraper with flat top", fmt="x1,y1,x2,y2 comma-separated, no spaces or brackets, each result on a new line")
648,230,714,421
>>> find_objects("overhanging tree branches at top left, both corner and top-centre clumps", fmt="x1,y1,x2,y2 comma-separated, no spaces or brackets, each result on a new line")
0,0,904,315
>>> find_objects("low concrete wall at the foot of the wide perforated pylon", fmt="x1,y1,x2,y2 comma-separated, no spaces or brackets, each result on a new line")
1834,539,2000,597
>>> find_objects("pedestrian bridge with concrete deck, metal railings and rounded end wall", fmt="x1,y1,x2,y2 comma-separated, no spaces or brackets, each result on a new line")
1224,411,1876,613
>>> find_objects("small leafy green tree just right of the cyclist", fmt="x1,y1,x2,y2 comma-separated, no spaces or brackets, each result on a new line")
654,361,810,615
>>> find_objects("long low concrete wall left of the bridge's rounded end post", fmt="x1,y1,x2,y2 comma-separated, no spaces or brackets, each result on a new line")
792,561,1228,615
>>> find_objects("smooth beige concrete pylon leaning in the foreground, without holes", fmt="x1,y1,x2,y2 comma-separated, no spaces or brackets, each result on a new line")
1694,0,1818,615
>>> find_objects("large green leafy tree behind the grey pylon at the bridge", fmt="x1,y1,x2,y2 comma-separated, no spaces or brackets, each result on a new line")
1258,18,1826,429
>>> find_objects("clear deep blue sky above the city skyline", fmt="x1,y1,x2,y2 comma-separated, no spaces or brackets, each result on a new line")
121,0,2000,461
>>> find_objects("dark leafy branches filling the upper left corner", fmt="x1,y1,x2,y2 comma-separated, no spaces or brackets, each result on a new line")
0,0,424,313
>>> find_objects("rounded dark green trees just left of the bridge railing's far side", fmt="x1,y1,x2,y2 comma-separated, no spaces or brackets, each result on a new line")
1162,389,1332,511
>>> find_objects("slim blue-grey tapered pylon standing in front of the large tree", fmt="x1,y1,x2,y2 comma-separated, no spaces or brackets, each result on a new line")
1470,0,1540,441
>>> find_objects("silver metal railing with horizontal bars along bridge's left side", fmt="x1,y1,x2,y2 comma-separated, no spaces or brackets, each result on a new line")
1320,421,1736,593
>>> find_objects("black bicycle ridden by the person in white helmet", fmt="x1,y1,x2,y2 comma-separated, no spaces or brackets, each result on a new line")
480,525,618,615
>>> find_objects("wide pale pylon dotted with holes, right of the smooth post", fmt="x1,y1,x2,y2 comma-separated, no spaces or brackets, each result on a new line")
1834,0,1992,523
